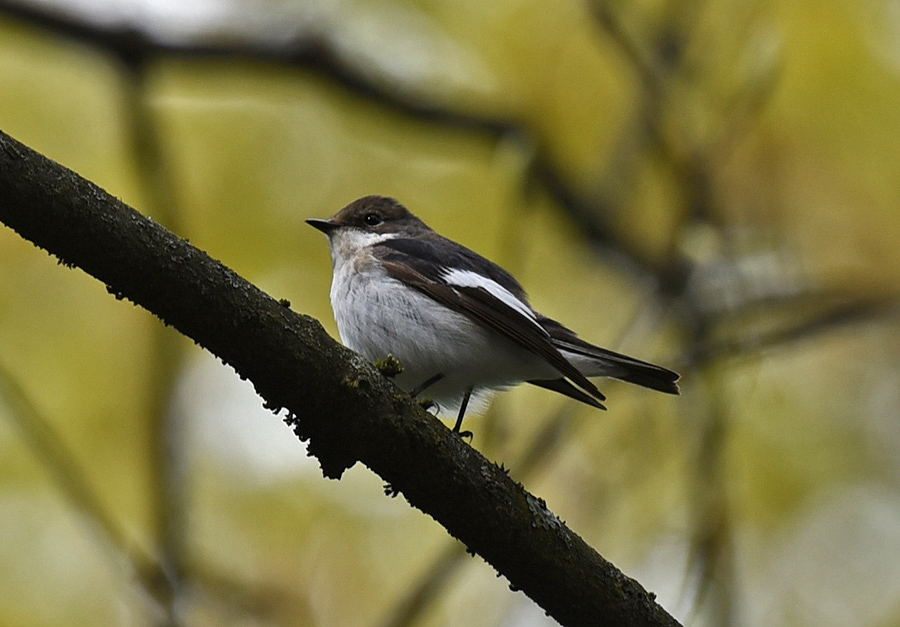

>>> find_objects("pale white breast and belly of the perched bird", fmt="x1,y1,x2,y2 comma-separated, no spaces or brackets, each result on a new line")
331,264,560,413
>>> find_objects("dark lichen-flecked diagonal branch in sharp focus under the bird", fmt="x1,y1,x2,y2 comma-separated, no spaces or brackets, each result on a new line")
0,132,677,625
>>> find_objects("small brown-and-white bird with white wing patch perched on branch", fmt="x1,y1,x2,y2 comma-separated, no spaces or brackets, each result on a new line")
307,196,678,432
